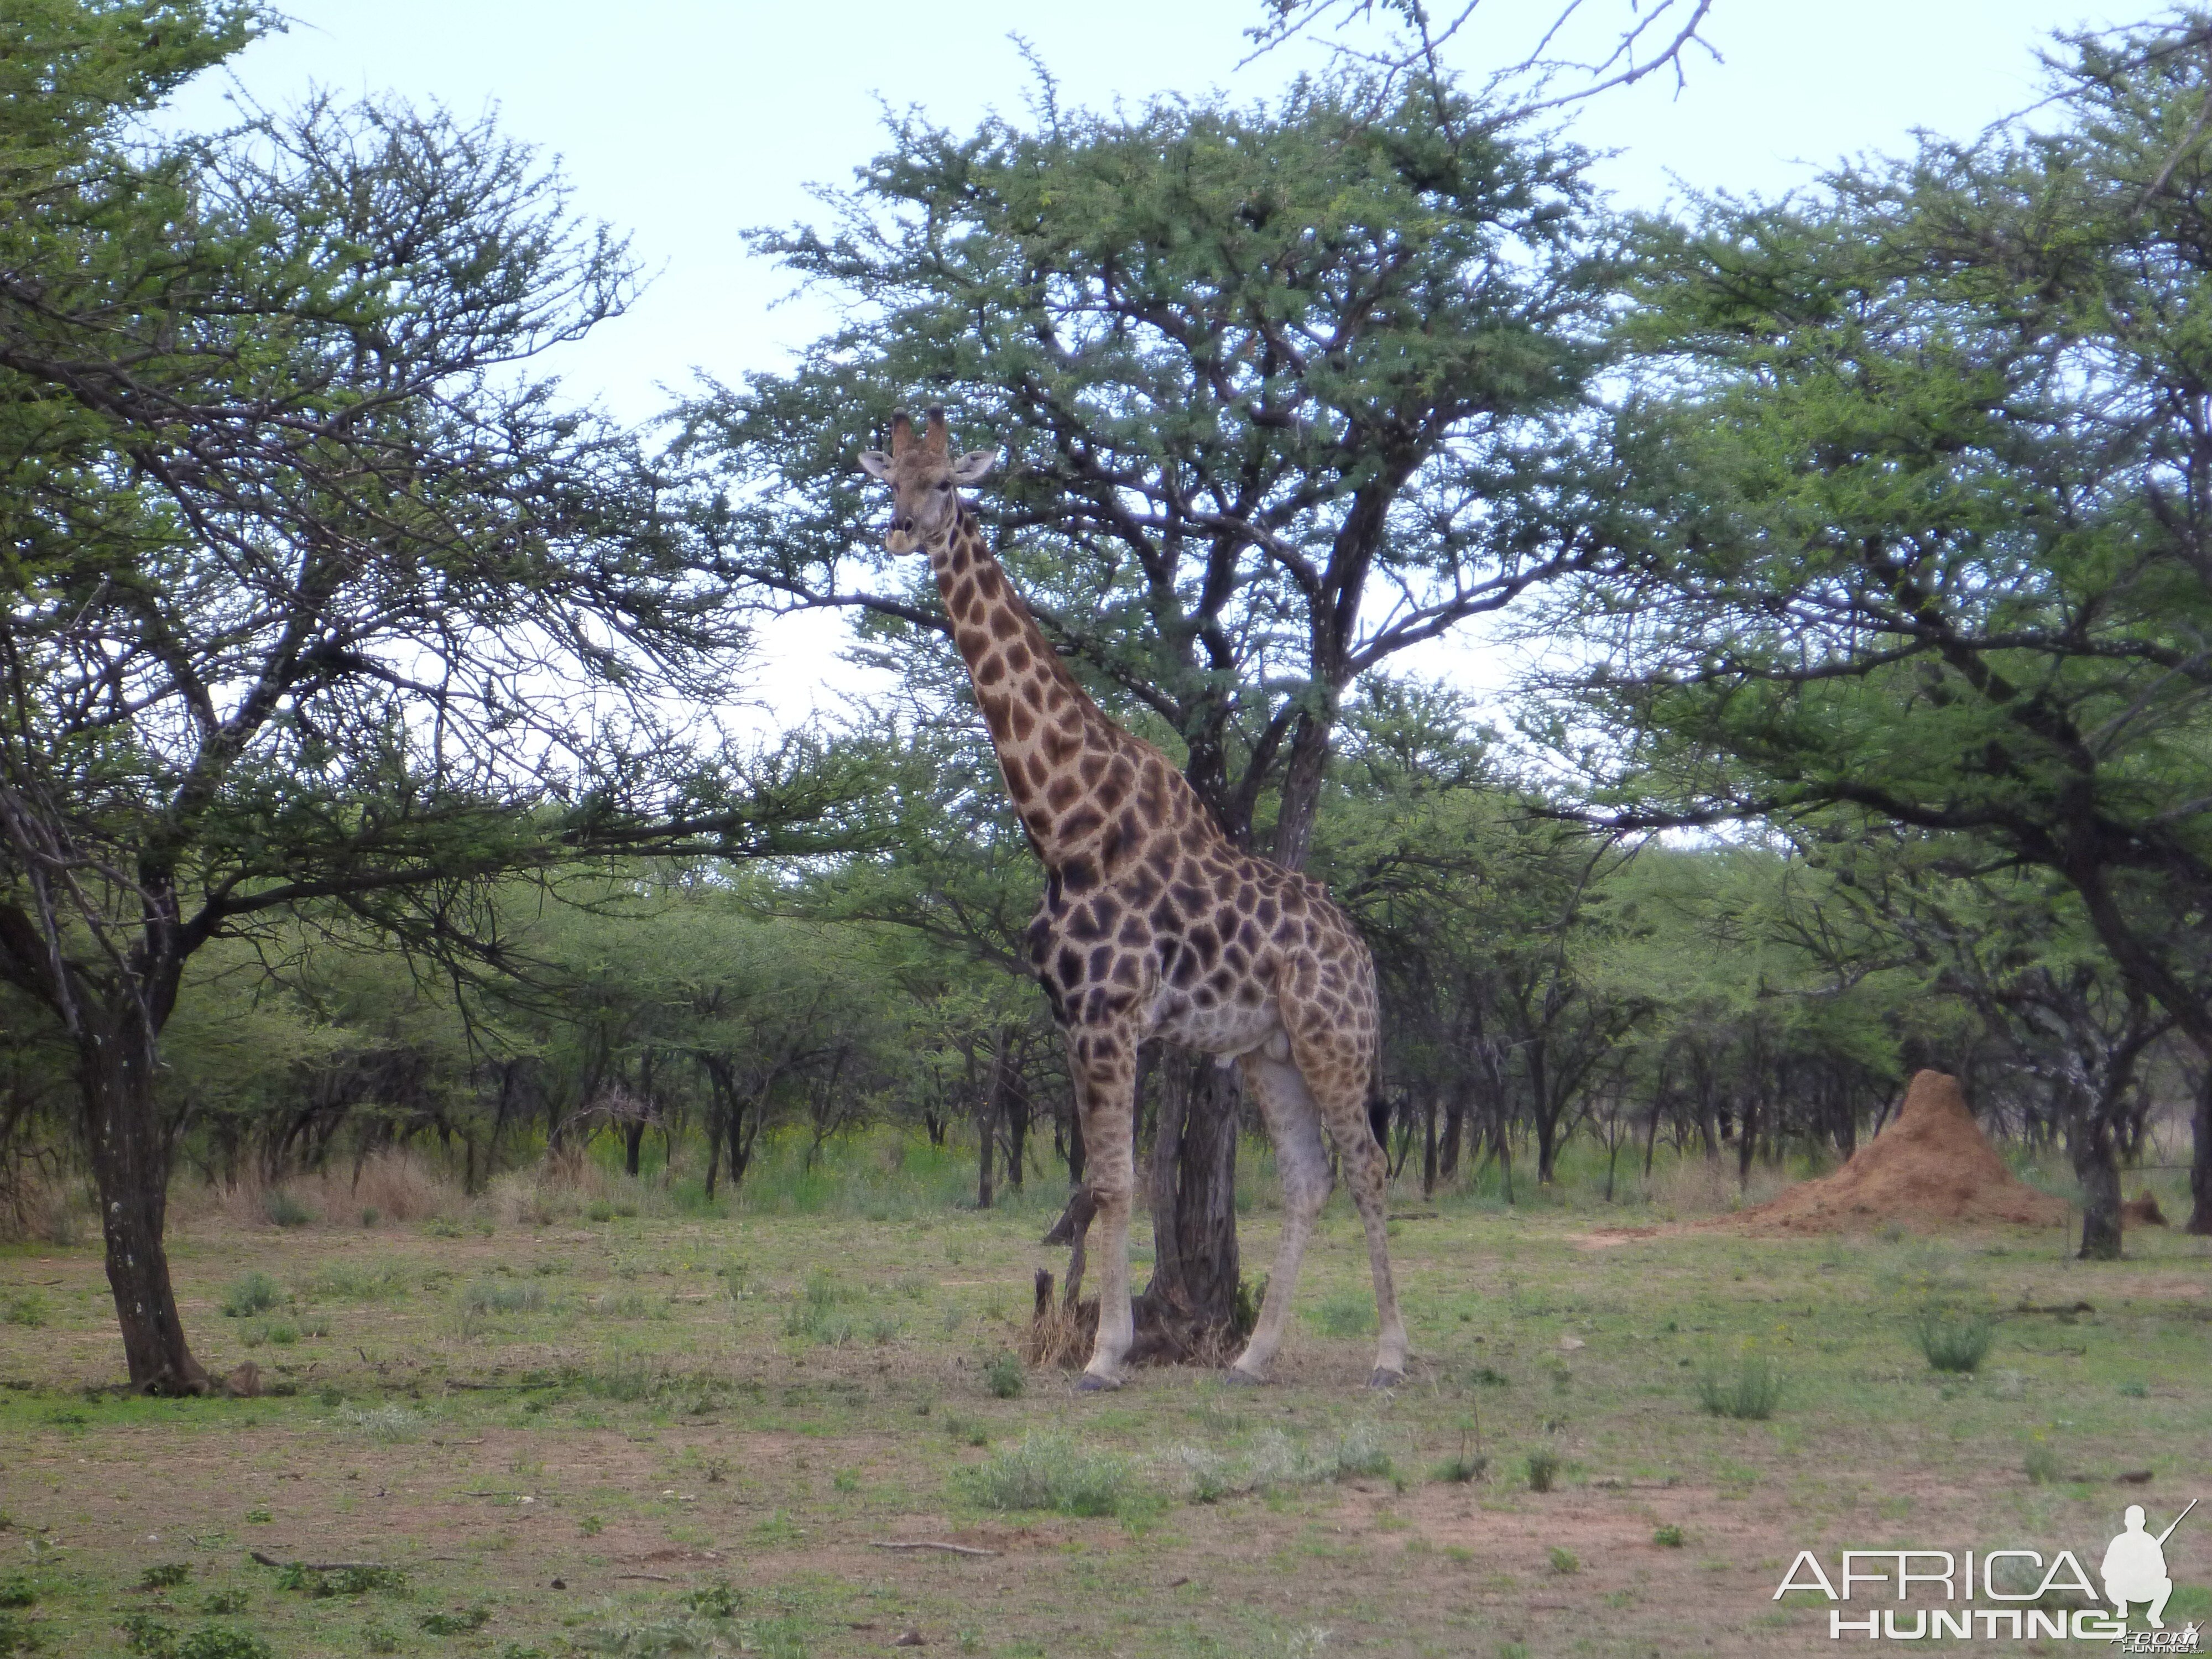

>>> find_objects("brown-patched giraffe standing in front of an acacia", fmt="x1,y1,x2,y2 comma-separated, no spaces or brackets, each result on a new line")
860,409,1407,1391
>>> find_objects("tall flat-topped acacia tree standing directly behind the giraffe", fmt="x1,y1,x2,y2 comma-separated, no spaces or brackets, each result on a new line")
688,75,1604,1354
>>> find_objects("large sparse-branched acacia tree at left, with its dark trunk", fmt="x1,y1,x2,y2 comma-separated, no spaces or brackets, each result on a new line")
0,0,854,1389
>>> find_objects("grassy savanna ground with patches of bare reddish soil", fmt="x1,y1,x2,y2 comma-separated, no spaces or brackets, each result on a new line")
0,1137,2212,1659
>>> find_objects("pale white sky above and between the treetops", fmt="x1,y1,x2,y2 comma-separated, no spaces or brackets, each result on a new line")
177,0,2143,717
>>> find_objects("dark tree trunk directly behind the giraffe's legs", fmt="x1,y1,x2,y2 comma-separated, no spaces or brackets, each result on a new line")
1135,1051,1243,1360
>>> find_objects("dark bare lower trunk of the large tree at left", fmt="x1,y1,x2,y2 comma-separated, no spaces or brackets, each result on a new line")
77,1011,208,1394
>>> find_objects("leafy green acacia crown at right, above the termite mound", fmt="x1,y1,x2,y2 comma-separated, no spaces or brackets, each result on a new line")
1584,13,2212,1230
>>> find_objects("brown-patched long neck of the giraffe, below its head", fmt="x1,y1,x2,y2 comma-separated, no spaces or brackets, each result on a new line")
929,502,1150,872
